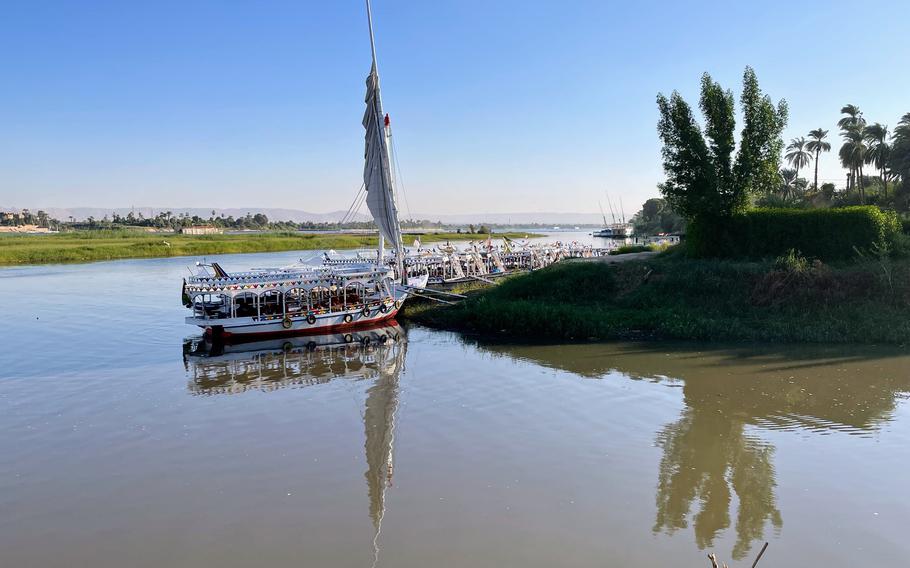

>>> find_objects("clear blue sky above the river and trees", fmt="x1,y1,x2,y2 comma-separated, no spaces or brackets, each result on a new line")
0,0,910,219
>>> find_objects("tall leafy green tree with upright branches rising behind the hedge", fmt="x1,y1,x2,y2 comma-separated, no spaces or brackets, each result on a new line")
657,67,787,220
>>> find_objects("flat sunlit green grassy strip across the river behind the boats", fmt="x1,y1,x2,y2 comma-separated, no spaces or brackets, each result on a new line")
0,230,526,265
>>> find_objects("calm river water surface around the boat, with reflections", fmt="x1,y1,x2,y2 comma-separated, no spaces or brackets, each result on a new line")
0,253,910,568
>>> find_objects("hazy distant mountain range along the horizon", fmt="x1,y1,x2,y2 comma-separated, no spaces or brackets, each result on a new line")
0,206,612,226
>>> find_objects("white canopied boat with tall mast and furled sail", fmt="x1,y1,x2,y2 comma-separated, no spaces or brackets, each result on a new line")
181,3,429,339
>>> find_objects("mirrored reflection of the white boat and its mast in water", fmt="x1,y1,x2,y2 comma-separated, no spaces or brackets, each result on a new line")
183,320,407,559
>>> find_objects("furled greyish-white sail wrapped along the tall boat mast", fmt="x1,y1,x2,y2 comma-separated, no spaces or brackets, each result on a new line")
363,59,401,250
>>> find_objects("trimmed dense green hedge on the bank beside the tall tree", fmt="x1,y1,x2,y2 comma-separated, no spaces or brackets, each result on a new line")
686,206,901,260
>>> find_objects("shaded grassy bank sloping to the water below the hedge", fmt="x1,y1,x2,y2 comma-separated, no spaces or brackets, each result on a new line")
405,255,910,344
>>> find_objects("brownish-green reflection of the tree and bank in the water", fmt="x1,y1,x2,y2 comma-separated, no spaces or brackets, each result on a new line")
464,343,910,560
